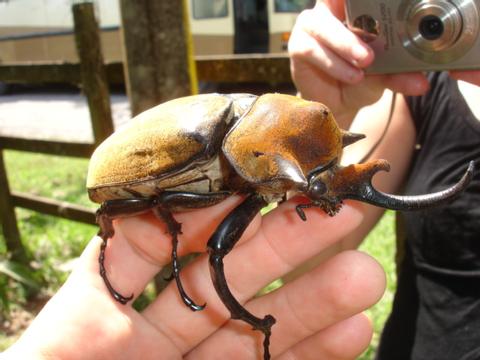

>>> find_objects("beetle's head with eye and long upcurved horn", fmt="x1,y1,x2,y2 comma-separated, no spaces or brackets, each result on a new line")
296,160,474,220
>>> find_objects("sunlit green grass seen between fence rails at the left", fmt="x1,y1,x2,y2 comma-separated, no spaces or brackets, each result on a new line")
0,151,97,351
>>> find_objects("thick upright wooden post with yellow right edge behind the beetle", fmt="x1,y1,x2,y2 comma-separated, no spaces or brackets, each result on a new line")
120,0,197,115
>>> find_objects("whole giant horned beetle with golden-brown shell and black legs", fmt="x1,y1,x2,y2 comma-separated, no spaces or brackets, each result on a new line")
87,94,474,359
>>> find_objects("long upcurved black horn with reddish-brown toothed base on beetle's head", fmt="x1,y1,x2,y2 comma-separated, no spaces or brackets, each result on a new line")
337,160,475,210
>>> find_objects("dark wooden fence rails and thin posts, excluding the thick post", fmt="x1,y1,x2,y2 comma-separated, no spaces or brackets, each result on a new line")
0,3,291,263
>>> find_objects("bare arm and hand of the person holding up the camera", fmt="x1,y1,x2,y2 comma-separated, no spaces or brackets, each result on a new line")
285,0,418,281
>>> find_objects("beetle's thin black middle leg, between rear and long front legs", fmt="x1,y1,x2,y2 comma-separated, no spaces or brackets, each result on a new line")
153,206,206,311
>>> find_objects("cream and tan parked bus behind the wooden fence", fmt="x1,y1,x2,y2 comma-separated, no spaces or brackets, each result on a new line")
0,0,315,64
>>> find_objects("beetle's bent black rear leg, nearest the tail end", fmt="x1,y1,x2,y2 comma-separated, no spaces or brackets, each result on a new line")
96,198,158,305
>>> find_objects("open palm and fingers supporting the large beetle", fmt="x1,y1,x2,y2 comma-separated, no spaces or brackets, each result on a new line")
0,197,385,359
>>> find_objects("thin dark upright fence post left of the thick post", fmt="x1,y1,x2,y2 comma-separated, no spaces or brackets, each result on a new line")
72,2,113,144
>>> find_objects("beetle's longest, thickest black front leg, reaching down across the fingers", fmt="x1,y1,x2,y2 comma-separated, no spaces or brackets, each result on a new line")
207,195,275,360
